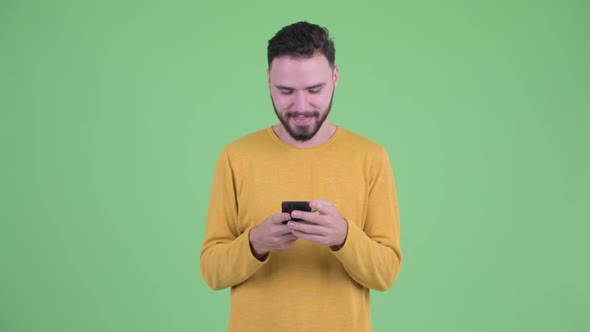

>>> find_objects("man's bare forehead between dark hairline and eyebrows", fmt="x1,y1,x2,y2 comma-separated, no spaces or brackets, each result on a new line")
269,53,332,87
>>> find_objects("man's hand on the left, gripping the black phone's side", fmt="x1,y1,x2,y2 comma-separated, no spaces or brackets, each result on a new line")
250,212,297,260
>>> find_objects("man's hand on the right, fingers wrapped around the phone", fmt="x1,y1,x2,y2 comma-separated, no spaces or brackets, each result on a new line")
287,200,348,249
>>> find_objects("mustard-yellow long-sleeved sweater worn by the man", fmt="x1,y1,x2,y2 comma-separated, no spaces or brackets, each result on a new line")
201,127,402,332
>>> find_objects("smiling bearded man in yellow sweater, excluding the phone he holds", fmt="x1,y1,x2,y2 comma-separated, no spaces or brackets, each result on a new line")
201,22,402,332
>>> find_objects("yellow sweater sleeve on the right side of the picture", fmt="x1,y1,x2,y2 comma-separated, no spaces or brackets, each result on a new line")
333,148,402,291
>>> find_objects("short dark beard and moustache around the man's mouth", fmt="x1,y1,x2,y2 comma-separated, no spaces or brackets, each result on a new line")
270,91,334,142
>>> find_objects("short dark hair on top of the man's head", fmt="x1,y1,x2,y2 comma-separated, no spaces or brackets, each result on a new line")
267,21,336,68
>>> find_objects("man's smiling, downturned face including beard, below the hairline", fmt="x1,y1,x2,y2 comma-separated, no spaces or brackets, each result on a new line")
268,53,338,142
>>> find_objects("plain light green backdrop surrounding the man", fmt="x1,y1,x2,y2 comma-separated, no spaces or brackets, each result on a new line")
0,0,590,332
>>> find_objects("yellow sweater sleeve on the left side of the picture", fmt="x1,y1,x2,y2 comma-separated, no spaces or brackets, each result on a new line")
200,149,270,290
